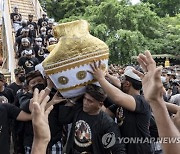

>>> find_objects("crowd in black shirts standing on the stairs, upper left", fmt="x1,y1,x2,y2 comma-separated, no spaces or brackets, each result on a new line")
11,7,57,73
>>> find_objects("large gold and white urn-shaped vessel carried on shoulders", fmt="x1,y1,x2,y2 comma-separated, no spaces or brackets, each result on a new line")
42,20,109,98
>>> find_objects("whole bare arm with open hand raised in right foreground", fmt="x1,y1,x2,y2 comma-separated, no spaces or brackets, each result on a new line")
134,51,180,154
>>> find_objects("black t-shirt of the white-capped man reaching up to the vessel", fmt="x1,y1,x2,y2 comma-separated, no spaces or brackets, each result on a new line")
109,95,152,154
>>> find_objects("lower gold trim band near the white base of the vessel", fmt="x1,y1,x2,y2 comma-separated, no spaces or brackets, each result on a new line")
58,79,97,92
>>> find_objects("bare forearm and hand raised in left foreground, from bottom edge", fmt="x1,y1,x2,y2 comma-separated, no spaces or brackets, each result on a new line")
31,89,53,154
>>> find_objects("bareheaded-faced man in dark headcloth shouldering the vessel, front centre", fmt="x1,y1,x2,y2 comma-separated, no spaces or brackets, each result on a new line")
59,84,126,154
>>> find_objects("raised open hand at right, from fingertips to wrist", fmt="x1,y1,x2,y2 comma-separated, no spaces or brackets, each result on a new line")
133,51,164,103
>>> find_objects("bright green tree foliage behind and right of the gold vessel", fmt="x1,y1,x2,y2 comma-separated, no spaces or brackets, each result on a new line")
41,0,180,64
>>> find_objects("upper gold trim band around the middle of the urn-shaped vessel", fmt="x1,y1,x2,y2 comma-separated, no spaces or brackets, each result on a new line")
45,54,109,75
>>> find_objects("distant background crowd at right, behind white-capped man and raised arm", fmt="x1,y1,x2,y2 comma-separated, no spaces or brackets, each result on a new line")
109,64,180,106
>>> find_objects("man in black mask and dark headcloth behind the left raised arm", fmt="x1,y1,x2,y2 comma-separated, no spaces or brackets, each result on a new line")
19,71,62,153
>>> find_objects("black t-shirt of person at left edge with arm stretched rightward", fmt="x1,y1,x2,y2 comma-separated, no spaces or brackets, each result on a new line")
0,103,21,154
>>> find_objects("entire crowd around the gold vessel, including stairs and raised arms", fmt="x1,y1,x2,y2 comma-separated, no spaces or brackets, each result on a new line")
0,5,180,154
